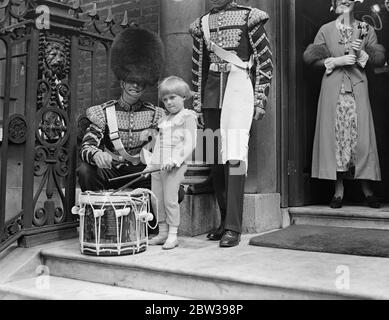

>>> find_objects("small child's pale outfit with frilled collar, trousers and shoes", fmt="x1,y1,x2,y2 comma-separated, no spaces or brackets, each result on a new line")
148,109,197,249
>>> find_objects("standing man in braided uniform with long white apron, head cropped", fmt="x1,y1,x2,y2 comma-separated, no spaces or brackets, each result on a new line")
190,0,273,247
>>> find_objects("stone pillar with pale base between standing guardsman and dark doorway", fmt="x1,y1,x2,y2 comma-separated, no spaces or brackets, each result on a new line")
238,0,282,232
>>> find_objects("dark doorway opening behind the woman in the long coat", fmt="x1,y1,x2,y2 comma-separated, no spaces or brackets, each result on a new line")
288,0,389,206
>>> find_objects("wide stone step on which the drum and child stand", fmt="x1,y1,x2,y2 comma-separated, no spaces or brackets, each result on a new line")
37,240,386,300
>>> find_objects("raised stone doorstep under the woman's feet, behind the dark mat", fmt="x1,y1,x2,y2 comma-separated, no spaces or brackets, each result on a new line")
289,205,389,230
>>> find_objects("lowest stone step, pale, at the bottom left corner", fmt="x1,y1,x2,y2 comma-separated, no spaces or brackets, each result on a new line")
0,276,182,300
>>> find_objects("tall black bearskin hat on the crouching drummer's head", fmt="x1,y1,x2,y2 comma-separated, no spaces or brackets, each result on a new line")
111,27,165,86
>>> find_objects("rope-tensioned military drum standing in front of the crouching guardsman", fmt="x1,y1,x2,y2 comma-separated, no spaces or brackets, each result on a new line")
72,189,153,256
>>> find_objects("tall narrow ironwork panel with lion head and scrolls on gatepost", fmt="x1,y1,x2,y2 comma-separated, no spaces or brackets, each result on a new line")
33,31,71,227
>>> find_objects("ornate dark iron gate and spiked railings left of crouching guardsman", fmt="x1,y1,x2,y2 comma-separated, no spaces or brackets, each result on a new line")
0,0,147,252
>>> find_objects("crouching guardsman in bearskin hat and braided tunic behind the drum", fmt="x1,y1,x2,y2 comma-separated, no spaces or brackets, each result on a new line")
77,28,165,191
